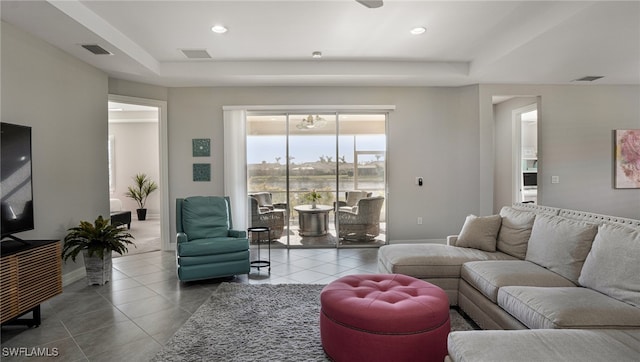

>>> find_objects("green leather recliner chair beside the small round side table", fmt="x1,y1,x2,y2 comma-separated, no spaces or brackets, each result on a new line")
176,196,250,281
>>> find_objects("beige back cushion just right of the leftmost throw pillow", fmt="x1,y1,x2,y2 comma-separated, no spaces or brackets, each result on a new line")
496,206,536,259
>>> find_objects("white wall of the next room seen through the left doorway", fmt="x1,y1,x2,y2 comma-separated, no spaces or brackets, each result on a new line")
109,122,160,218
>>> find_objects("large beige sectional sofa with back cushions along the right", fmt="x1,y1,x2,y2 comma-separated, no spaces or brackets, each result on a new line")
378,204,640,361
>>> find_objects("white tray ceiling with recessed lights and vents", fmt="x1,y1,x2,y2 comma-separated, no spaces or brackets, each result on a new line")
1,0,640,86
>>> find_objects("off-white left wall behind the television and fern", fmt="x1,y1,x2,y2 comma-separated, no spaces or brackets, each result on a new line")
0,22,109,273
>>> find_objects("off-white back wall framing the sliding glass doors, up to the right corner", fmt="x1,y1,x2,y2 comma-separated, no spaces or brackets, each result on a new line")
168,87,479,240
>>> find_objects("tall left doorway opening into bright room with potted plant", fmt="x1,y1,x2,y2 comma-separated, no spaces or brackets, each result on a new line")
108,96,170,255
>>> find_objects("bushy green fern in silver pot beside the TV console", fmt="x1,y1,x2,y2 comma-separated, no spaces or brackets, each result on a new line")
62,215,136,285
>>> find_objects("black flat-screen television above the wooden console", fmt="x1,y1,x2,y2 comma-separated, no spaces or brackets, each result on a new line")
0,122,34,238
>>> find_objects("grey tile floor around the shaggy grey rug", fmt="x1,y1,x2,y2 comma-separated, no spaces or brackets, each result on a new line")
0,245,378,362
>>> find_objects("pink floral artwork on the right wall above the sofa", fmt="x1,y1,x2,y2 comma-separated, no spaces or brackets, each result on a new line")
614,129,640,189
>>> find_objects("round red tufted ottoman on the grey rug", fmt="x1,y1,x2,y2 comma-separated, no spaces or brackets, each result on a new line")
320,274,450,362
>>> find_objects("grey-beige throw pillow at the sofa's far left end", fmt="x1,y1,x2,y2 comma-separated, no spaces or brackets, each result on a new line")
456,215,502,252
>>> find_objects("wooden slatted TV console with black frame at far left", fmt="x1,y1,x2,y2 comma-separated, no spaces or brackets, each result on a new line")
0,240,62,326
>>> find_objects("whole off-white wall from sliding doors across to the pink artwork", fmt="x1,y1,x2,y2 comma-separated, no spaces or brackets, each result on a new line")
169,86,640,245
